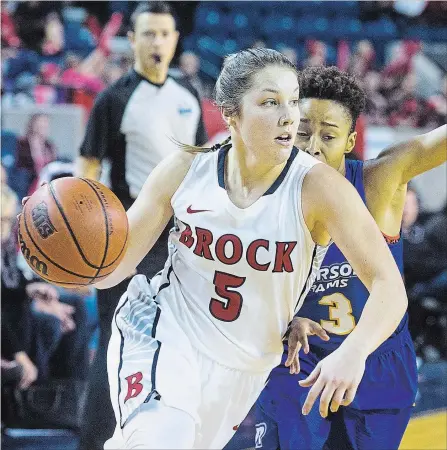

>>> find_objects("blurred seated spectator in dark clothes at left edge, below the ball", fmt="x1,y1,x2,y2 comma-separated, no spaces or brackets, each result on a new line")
1,185,88,389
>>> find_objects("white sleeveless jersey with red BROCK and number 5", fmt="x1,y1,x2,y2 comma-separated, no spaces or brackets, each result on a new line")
153,149,325,372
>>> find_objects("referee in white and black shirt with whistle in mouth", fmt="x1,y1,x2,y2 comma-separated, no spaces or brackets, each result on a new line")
76,2,207,450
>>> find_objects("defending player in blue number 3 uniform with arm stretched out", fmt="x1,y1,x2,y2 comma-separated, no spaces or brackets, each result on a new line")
255,67,447,450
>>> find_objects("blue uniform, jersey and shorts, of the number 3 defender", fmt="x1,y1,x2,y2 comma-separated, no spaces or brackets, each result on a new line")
256,160,417,450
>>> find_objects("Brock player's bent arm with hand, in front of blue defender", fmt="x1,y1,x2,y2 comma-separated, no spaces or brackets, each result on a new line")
300,164,408,417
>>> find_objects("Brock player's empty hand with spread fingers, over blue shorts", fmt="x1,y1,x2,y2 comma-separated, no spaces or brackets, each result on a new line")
299,346,366,417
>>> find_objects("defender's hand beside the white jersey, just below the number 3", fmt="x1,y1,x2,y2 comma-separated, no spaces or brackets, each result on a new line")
285,317,329,374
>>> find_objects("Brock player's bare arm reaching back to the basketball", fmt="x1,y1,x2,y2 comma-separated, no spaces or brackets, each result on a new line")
94,152,195,289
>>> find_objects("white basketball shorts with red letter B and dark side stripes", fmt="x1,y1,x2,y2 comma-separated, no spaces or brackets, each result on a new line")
105,275,269,449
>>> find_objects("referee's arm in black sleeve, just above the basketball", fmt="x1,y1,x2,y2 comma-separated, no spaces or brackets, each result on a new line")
75,90,115,180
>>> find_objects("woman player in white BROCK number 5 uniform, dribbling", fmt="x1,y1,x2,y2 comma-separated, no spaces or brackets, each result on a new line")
96,49,407,449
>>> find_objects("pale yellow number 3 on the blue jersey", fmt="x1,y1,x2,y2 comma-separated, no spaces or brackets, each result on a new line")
318,293,355,335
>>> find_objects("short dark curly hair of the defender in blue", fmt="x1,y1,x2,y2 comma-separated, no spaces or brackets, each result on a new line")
298,66,366,133
